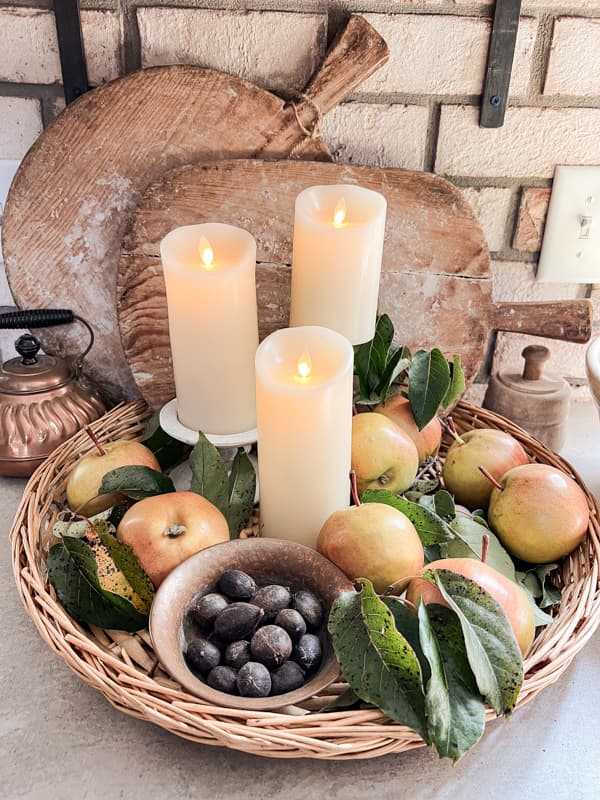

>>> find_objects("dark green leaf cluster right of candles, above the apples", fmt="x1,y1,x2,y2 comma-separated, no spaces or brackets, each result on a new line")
354,314,465,429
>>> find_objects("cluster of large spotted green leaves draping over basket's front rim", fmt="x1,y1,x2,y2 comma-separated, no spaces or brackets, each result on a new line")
329,570,523,761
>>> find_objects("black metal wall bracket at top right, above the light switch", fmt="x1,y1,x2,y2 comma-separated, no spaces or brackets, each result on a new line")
479,0,521,128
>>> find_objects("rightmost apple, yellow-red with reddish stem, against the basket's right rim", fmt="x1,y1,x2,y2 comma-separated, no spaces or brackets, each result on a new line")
488,464,590,564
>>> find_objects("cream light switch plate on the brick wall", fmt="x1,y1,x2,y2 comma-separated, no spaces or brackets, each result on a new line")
537,166,600,283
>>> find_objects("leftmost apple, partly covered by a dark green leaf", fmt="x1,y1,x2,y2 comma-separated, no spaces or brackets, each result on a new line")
67,428,160,517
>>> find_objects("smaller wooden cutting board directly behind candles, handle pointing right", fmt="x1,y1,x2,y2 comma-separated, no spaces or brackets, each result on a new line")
117,155,591,408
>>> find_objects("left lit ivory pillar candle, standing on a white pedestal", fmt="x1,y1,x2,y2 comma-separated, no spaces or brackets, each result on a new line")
160,223,258,435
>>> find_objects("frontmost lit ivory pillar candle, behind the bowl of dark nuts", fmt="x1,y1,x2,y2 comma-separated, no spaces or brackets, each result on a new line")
256,326,353,547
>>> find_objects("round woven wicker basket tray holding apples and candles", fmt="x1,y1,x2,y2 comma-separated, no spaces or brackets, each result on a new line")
11,402,600,759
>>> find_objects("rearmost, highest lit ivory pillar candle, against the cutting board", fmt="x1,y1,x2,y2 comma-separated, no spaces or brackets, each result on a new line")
290,184,387,344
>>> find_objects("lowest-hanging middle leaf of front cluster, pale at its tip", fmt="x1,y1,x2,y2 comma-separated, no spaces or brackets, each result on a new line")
419,603,485,763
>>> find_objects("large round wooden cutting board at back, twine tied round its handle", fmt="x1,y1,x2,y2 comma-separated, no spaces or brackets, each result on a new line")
2,17,387,400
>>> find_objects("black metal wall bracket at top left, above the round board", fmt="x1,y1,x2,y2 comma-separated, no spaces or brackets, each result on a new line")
54,0,89,105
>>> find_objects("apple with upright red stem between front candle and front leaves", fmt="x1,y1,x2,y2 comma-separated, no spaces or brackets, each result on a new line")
316,503,423,592
